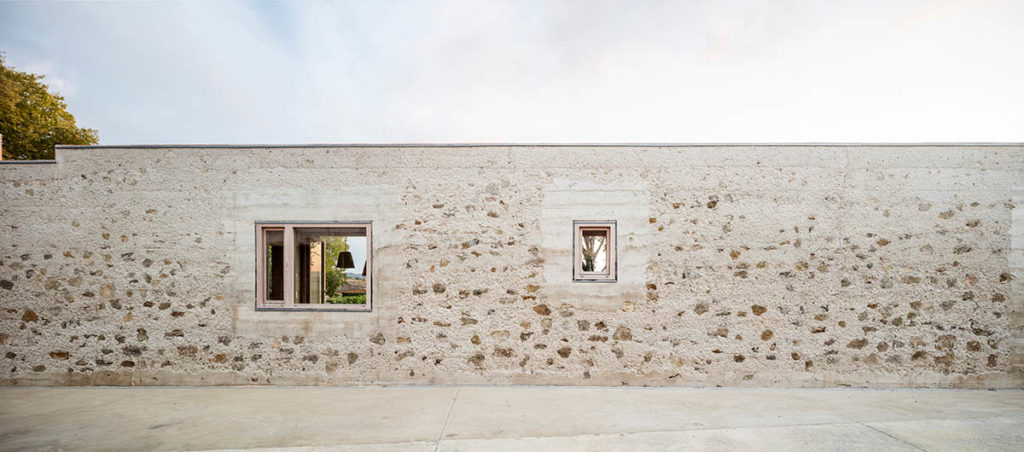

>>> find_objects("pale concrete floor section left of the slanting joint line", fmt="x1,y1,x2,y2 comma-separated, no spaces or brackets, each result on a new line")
0,387,457,450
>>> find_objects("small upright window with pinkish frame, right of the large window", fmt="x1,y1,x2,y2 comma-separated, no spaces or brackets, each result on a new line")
572,221,617,282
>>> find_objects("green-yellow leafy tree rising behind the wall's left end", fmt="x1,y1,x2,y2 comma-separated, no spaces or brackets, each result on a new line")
0,53,99,160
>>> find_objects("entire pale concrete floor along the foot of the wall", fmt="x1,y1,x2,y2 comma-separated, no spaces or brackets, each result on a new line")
0,386,1024,452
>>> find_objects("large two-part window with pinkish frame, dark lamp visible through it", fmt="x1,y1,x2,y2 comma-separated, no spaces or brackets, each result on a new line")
256,222,373,311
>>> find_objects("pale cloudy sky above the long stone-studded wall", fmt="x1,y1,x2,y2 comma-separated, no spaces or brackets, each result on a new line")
0,0,1024,145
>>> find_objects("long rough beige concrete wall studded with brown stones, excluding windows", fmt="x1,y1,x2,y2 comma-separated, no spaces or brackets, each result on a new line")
0,146,1024,387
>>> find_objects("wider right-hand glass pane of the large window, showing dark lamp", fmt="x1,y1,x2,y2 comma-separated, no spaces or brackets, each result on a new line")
295,228,367,304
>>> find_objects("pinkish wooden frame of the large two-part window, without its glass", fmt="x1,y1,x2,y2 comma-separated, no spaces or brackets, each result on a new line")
256,221,374,313
